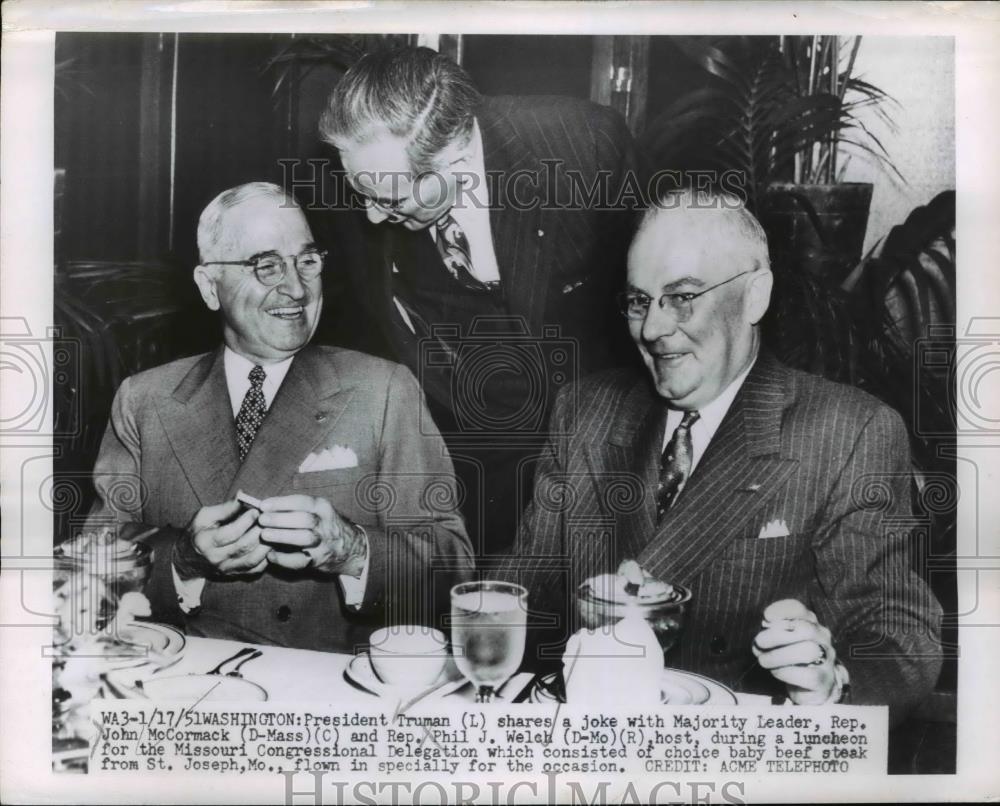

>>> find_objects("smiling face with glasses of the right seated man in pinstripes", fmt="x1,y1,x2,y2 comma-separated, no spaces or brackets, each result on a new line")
626,209,771,410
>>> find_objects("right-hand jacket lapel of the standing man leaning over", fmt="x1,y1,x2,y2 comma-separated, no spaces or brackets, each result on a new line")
476,99,555,331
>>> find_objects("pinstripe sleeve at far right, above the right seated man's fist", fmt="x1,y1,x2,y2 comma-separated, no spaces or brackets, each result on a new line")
810,407,941,722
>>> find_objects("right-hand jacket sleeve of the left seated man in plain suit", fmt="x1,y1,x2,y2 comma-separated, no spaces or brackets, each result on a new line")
359,366,473,624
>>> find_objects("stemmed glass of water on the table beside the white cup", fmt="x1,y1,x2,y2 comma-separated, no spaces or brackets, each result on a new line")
451,580,528,702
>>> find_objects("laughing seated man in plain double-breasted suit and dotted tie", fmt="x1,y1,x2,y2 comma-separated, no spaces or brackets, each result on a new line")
88,183,471,651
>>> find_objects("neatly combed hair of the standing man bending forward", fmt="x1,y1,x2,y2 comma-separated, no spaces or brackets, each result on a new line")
319,47,481,173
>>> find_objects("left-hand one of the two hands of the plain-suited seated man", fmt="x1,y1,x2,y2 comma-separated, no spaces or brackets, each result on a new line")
173,500,270,579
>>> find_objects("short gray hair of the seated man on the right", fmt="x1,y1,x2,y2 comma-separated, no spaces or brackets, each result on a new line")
639,187,771,270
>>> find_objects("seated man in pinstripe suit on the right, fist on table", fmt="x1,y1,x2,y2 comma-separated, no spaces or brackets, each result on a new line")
517,191,941,719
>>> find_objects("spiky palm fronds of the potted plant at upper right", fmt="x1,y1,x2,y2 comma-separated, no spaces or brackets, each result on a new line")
644,36,902,211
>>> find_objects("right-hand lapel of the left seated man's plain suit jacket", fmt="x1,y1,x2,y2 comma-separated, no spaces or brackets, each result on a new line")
226,347,352,498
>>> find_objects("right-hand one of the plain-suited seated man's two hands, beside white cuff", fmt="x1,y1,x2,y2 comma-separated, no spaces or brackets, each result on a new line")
258,495,368,576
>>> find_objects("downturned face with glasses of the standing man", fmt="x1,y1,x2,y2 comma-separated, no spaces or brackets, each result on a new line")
340,133,463,231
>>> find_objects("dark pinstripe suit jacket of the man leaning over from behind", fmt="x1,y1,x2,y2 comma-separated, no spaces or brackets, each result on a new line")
364,96,635,405
